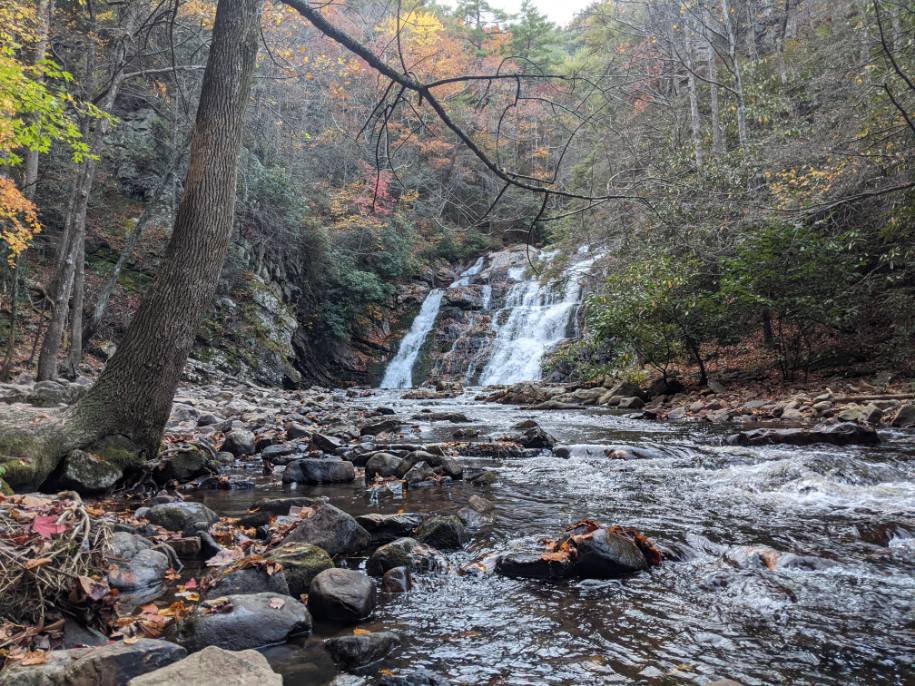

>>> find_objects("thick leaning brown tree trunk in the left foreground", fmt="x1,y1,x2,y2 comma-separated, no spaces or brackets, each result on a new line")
68,0,261,456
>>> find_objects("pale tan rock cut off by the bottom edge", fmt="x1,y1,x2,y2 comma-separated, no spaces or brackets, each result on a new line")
127,646,283,686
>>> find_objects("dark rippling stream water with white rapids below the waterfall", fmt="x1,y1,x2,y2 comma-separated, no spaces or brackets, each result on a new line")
195,390,915,686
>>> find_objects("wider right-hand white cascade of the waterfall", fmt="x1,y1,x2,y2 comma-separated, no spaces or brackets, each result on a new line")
480,253,596,386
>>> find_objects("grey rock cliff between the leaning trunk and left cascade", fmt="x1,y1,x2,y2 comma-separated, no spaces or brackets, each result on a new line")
194,243,460,387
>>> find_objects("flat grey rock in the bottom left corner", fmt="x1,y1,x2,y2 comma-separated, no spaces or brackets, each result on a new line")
0,638,187,686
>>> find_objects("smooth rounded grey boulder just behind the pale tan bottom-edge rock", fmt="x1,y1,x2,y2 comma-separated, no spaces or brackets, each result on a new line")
177,593,311,652
